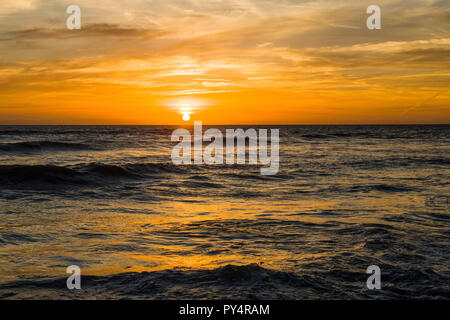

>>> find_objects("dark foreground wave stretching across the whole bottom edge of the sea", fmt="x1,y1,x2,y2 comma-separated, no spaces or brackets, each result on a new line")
0,262,450,300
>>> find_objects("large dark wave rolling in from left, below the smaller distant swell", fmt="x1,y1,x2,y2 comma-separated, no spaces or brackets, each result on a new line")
0,162,278,192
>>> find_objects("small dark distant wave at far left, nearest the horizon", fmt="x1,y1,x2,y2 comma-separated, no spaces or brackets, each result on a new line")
0,140,95,152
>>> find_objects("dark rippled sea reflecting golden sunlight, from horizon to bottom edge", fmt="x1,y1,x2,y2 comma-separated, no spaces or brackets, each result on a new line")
0,126,450,299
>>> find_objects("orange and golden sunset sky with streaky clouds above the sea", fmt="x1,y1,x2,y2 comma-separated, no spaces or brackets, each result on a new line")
0,0,450,125
